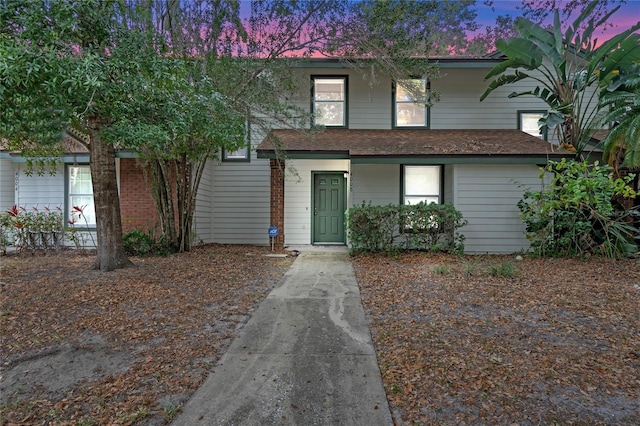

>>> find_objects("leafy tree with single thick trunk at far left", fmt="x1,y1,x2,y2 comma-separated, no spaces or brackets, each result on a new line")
0,0,136,271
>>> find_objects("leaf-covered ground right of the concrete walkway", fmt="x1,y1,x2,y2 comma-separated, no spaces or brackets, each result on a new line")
353,253,640,425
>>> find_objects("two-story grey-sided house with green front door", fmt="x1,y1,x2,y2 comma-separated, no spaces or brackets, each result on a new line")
0,57,570,253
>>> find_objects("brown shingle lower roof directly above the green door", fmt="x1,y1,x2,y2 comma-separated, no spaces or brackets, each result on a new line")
257,129,569,158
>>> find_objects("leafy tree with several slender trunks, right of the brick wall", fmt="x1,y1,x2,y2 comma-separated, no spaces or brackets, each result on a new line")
103,3,245,252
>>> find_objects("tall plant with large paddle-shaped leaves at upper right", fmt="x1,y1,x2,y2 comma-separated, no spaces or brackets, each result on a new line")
480,1,640,154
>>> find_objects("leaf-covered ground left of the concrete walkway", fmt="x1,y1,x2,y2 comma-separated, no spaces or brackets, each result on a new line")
0,245,292,425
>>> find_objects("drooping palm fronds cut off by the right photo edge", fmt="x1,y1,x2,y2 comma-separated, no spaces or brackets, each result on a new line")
599,64,640,172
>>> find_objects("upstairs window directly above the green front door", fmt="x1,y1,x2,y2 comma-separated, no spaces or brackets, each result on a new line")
311,76,347,127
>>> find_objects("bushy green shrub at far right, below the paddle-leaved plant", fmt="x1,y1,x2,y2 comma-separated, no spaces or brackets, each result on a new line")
518,159,640,258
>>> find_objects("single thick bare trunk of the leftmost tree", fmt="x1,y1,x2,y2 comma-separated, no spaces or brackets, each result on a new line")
88,116,133,271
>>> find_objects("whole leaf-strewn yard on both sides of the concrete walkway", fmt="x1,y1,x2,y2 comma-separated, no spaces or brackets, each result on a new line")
0,245,640,425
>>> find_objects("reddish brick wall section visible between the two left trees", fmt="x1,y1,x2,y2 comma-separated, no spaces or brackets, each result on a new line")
120,158,158,232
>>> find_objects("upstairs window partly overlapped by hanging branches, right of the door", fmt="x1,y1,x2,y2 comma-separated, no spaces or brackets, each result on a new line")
393,78,429,127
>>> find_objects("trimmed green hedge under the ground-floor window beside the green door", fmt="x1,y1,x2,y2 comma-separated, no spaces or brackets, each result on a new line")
347,203,467,253
